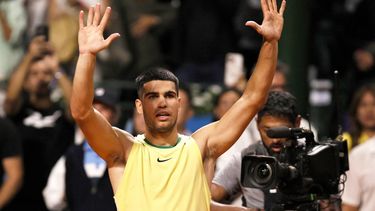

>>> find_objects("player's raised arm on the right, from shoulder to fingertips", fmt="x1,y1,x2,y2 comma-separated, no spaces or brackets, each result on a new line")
193,0,286,158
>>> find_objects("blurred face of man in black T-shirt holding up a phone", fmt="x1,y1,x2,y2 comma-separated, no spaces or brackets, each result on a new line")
25,57,53,98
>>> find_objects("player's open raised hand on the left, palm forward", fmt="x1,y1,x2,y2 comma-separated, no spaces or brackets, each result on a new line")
78,4,120,54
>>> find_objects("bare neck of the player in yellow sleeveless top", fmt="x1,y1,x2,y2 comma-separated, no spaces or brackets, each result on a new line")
145,130,178,146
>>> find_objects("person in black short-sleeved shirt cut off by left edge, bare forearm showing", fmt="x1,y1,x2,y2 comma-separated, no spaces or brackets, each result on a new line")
0,117,23,210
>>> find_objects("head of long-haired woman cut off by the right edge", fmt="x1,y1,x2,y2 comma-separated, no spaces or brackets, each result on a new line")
343,84,375,150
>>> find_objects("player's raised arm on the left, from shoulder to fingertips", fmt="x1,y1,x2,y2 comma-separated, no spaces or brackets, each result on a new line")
70,4,130,167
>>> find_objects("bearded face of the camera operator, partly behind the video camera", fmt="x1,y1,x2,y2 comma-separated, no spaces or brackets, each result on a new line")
257,115,298,154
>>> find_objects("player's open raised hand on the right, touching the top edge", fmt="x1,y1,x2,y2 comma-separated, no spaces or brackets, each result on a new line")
245,0,286,42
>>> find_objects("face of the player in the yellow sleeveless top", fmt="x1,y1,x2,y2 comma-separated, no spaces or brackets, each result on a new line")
136,80,180,132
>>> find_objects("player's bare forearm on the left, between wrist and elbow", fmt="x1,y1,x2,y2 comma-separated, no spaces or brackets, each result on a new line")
70,53,96,118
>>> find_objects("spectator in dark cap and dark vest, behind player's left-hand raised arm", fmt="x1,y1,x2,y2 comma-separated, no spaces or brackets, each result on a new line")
43,87,120,211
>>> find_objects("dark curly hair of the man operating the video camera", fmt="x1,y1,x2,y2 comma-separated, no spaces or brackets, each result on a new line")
258,91,299,123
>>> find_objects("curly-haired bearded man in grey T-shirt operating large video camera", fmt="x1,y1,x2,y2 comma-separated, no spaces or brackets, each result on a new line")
211,91,301,209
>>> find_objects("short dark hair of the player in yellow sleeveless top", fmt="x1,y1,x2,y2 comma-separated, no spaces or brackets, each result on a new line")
135,67,179,98
